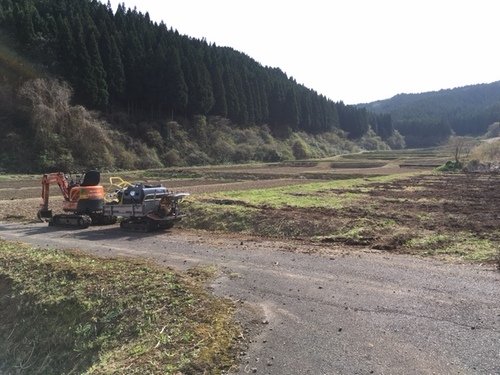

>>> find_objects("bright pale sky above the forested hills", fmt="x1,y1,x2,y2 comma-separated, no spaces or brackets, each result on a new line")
101,0,500,104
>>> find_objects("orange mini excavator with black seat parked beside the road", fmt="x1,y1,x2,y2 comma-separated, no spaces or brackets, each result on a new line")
38,171,116,228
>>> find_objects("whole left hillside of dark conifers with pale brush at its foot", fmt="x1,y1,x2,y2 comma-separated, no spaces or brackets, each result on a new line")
0,0,498,172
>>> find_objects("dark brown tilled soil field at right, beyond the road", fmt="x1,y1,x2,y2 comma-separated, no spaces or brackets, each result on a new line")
219,174,500,251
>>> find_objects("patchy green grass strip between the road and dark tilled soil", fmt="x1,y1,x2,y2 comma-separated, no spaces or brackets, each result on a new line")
181,172,500,267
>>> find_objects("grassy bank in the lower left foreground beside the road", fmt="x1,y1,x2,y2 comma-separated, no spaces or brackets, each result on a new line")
0,241,241,374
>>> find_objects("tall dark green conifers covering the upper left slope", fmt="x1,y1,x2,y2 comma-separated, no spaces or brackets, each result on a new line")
0,0,394,140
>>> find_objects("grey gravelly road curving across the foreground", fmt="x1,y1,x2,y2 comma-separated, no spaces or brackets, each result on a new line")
0,222,500,375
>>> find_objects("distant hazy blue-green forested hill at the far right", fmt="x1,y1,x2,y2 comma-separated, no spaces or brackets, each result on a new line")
359,81,500,147
